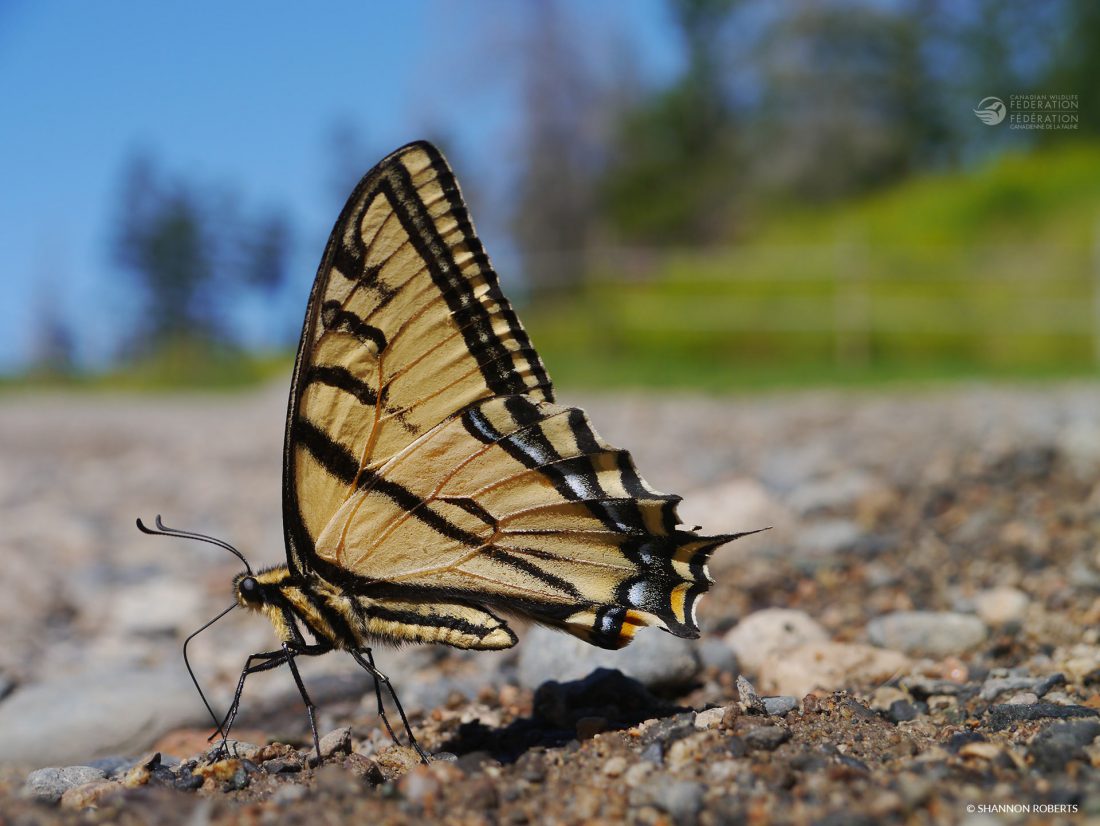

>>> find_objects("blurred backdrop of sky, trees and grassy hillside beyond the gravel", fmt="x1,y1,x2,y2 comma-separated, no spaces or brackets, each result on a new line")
0,0,1100,389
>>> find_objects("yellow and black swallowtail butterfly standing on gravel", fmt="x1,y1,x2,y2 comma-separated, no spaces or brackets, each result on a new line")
138,142,743,759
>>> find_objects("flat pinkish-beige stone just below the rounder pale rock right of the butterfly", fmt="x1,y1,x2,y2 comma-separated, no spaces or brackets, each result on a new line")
760,642,912,697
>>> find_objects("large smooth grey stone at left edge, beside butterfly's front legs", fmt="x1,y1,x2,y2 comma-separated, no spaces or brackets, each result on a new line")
0,664,209,766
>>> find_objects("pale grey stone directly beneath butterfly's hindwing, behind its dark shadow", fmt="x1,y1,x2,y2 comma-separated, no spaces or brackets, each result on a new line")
519,626,701,691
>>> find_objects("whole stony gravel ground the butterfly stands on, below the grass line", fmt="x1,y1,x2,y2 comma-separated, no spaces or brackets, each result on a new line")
0,385,1100,824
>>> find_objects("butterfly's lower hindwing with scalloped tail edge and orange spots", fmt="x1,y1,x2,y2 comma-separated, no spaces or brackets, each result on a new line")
317,396,732,648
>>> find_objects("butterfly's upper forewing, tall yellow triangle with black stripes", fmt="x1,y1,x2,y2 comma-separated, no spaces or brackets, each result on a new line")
284,143,552,573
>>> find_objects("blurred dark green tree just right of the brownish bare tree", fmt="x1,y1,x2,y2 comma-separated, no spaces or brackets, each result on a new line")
601,0,741,243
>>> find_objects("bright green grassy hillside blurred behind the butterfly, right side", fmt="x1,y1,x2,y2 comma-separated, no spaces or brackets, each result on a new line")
525,145,1100,388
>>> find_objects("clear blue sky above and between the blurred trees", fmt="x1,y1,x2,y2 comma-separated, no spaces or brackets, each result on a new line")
0,0,681,371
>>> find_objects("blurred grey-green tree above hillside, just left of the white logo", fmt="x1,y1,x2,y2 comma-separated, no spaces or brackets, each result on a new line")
748,0,949,201
